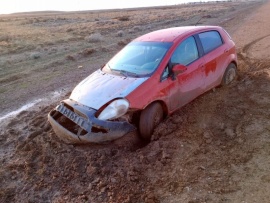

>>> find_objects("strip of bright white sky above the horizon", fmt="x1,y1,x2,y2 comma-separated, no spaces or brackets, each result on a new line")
0,0,228,14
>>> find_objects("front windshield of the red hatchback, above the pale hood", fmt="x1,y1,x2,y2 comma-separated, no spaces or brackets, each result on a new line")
102,42,172,77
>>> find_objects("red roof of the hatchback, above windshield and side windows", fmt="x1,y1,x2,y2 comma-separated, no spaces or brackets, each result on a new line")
134,26,220,42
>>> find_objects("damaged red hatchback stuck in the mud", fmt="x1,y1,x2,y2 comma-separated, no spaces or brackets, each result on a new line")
48,26,237,143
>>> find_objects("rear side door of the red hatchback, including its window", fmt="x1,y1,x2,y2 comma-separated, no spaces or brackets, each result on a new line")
198,30,228,90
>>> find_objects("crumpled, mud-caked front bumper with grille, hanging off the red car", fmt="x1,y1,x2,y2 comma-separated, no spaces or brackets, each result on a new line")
48,99,136,144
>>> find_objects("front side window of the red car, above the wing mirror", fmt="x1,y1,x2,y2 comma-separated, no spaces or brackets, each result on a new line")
171,37,199,66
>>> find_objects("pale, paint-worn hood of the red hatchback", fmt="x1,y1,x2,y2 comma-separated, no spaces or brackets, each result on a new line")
70,70,148,110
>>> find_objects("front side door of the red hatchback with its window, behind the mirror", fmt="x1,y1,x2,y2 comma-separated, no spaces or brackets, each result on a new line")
169,36,204,111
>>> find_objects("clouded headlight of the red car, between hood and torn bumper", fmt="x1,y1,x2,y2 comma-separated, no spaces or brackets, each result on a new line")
98,99,129,120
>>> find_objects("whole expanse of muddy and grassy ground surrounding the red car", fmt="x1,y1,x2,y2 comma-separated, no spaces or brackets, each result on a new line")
0,1,270,203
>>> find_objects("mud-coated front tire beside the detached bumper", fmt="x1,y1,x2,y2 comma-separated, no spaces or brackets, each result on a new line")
139,103,163,141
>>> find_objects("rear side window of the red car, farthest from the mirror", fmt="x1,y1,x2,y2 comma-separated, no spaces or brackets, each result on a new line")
199,31,223,53
